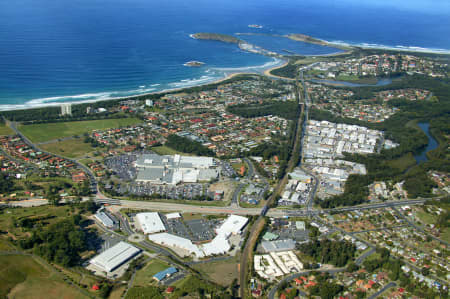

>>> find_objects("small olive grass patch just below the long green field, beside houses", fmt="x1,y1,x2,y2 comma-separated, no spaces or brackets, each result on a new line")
41,138,94,158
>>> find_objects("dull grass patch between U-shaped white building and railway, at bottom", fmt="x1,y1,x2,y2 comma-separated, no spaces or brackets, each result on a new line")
194,257,239,286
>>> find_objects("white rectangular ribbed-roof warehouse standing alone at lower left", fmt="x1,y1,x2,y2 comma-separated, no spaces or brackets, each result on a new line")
89,242,141,272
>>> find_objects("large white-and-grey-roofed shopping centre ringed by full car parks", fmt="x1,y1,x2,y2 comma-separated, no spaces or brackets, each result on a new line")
135,154,219,185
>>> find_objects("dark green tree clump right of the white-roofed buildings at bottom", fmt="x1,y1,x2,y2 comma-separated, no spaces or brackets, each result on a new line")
298,239,356,267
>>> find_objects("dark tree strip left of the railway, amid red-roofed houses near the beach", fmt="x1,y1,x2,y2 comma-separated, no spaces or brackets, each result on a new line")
227,101,300,119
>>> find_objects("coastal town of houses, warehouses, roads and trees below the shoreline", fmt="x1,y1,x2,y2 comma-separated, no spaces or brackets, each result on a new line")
0,44,450,299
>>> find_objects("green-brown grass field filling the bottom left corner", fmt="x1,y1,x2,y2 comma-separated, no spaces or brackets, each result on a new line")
0,255,86,299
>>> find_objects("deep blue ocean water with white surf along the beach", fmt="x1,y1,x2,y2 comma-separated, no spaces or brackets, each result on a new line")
0,0,450,109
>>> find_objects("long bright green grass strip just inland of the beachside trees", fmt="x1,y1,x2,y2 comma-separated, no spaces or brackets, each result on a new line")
19,118,142,142
